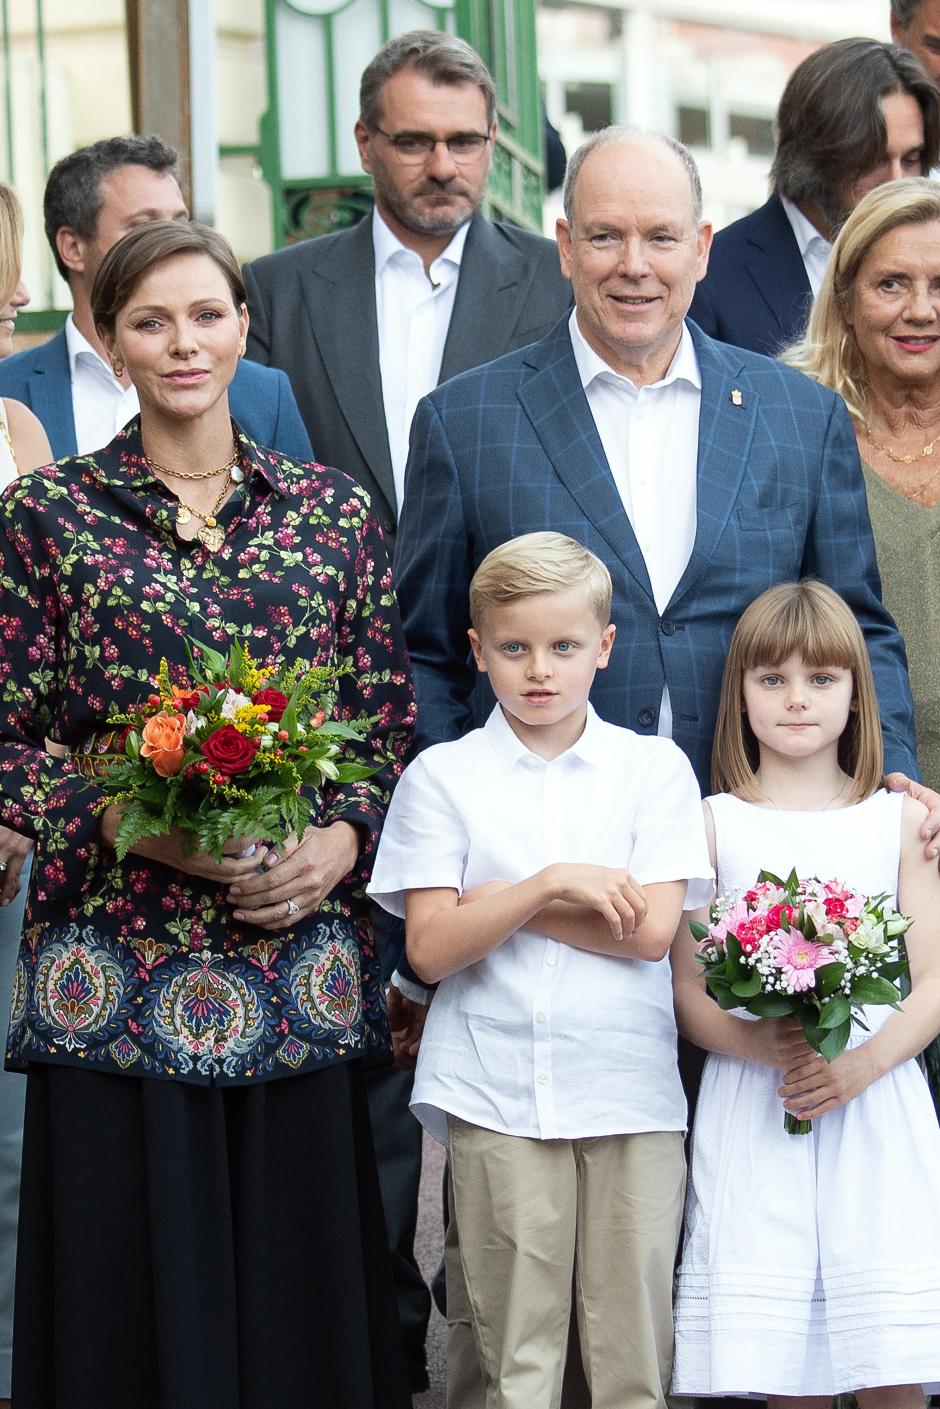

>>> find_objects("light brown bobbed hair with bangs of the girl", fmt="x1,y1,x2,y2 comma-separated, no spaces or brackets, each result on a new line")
712,578,884,802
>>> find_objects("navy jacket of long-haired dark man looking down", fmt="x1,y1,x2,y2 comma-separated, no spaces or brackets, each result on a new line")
689,196,813,356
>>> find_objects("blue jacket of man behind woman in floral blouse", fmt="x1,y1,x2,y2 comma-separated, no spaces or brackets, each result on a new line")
0,328,313,464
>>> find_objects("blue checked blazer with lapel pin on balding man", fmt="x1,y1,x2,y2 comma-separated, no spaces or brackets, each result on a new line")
395,317,917,789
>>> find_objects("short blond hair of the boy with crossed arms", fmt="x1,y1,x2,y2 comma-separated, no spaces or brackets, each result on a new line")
469,533,613,628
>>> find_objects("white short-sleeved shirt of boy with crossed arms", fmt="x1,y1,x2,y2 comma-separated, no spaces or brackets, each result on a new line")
369,706,712,1143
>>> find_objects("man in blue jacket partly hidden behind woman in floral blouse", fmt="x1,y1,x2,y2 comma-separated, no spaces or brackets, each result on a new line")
0,137,313,461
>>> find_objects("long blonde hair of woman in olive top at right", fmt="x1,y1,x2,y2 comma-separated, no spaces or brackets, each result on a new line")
782,179,940,423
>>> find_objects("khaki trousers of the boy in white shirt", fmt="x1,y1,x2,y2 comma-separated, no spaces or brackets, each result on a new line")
445,1116,685,1409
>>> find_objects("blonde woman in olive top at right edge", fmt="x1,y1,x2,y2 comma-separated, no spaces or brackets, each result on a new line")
785,180,940,1112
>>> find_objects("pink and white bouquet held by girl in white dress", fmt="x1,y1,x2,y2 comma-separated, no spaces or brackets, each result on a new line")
691,871,910,1134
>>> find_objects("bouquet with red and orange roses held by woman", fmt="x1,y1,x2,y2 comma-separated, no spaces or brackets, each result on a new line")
87,643,379,861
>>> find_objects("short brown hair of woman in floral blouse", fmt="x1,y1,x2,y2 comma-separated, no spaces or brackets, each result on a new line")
92,220,247,334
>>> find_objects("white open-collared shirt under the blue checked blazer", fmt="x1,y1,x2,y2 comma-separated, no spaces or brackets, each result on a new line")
568,309,702,738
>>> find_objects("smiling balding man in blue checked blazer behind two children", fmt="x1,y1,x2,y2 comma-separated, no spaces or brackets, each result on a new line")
396,128,916,789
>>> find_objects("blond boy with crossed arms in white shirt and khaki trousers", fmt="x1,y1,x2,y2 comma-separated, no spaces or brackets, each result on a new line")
369,533,712,1409
